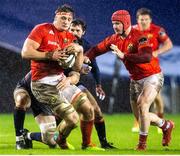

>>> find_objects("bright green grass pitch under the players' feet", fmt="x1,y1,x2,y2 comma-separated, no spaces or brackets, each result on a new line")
0,114,180,155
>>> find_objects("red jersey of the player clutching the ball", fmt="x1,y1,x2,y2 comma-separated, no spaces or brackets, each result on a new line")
28,23,76,80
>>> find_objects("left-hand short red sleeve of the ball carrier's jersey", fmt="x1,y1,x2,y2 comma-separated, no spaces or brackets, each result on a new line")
28,25,45,44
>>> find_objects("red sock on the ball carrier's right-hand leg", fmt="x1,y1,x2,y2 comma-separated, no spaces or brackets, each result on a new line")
80,120,94,146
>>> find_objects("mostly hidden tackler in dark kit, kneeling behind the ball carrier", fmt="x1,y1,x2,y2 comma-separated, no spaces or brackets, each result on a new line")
14,72,56,149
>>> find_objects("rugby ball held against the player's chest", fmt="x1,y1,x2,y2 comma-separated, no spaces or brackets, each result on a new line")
58,54,76,69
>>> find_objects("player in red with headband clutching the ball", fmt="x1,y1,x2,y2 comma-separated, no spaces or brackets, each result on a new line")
22,5,103,150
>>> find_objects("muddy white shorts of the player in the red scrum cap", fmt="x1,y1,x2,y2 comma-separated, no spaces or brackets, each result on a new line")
130,73,164,103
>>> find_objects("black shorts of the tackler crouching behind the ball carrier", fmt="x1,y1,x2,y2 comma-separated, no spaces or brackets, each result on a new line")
15,79,53,117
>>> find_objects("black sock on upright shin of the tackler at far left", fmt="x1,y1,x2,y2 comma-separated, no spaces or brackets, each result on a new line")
14,107,26,136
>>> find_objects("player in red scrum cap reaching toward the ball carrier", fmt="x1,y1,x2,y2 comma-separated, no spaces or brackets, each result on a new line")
86,10,174,150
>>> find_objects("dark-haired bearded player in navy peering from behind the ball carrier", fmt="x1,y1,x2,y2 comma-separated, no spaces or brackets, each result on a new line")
69,19,114,149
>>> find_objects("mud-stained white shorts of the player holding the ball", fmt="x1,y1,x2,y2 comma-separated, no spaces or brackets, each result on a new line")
31,81,81,118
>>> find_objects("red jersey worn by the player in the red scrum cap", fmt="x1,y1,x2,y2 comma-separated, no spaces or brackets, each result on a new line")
86,28,161,80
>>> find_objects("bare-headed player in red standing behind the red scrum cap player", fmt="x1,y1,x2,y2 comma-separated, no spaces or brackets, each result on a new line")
132,8,173,132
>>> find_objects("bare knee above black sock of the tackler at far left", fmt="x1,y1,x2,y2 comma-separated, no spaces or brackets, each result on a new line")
14,92,31,109
